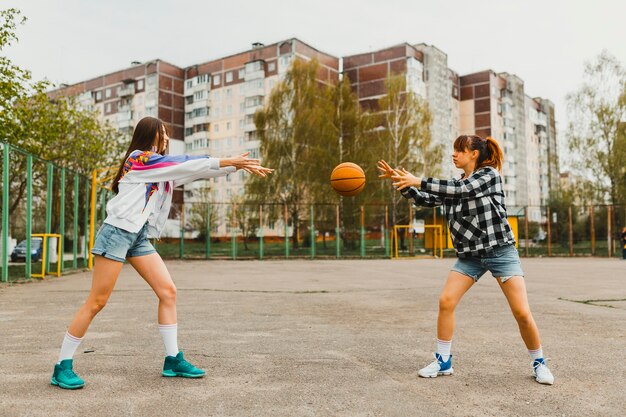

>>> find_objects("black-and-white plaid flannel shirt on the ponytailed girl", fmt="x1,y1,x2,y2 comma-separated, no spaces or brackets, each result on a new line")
401,167,515,258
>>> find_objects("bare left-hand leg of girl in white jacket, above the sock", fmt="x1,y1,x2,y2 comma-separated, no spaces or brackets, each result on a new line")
67,255,123,338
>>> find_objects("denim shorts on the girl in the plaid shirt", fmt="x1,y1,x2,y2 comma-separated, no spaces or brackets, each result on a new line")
452,245,524,283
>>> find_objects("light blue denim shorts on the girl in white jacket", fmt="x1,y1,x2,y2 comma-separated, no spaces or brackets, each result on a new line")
91,223,156,262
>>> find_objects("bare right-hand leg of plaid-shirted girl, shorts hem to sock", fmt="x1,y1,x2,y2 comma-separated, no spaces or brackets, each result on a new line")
496,276,541,350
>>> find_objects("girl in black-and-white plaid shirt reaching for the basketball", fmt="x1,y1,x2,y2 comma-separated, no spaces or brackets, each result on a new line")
378,135,554,385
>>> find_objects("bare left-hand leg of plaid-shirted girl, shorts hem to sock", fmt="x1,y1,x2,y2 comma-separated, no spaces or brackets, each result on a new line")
437,271,474,340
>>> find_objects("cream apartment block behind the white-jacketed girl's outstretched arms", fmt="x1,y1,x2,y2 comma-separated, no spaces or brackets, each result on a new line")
184,38,339,233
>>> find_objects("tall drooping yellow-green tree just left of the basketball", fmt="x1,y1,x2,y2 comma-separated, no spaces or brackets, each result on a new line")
246,60,338,248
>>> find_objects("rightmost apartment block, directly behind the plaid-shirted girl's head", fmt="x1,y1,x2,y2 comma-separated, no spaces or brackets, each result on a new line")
460,70,558,211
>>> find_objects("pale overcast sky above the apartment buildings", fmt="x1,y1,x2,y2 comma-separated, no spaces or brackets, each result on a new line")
0,0,626,154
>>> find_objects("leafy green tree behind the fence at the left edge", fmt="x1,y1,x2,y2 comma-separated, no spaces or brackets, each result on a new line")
0,9,124,237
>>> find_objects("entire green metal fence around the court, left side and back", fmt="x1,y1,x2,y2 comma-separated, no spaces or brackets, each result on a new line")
0,142,626,282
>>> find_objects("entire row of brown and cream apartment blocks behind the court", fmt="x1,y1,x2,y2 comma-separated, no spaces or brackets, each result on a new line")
50,38,559,230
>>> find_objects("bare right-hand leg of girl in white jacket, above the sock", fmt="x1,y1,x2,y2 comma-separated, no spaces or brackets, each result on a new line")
127,253,176,324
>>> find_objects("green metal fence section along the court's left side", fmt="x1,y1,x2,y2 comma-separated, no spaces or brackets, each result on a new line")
0,142,103,282
